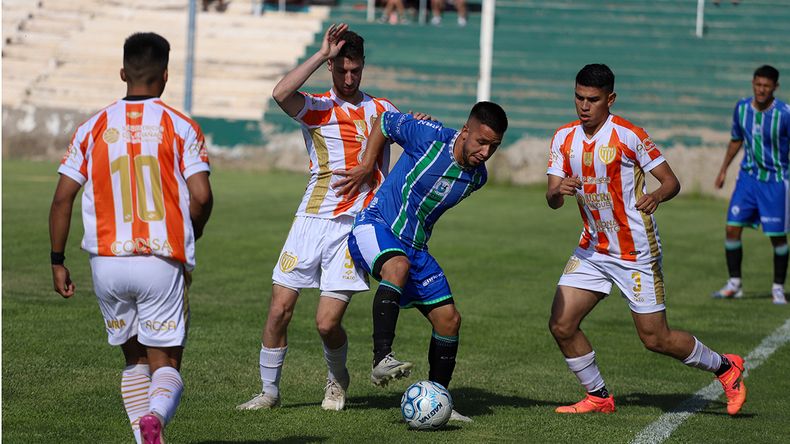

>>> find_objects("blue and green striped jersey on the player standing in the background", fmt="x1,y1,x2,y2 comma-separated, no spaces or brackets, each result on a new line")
732,97,790,182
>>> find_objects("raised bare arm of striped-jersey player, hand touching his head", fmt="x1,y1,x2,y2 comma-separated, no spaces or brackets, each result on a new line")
272,23,348,117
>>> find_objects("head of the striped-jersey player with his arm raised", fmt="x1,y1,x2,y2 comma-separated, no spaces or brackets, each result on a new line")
328,31,365,101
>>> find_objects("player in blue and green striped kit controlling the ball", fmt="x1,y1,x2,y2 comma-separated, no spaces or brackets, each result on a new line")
338,102,507,421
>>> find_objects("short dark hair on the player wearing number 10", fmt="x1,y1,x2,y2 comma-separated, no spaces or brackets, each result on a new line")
123,32,170,85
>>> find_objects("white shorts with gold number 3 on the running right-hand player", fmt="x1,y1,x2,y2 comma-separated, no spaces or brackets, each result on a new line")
557,248,666,314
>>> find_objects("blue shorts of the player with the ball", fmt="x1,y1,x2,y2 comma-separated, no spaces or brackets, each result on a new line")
348,219,453,308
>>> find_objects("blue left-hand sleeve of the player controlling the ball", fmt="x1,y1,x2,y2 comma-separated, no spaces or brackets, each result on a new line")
381,111,443,155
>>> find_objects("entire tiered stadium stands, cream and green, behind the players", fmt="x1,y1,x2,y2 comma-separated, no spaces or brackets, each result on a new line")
3,0,790,146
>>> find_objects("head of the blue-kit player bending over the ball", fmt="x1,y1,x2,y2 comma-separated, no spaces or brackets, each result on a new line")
458,102,507,167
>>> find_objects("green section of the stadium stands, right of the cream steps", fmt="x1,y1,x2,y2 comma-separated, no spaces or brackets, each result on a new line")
266,0,790,146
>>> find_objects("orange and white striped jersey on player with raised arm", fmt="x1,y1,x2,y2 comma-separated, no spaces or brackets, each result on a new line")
294,89,398,219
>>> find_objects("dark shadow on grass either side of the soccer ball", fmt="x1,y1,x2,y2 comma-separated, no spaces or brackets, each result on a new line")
346,387,562,416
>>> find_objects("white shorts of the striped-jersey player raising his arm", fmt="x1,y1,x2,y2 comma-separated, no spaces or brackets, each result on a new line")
272,216,370,299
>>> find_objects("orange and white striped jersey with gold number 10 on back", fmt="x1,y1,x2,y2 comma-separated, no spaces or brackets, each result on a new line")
58,98,209,270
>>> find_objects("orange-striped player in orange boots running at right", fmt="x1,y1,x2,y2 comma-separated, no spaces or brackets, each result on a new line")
546,64,746,415
